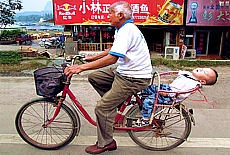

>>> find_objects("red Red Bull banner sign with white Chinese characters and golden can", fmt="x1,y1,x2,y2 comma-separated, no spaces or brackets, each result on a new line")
53,0,184,25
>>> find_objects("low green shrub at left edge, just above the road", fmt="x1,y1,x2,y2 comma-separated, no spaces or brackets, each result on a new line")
0,51,22,65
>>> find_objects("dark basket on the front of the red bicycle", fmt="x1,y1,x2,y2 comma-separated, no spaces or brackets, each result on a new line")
34,67,65,98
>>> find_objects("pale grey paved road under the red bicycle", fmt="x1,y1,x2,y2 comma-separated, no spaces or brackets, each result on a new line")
0,67,230,155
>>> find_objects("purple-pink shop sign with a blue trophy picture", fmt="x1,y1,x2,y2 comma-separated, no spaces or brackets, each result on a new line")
186,0,230,26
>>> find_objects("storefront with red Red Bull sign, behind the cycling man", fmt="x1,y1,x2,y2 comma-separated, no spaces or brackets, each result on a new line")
53,0,185,55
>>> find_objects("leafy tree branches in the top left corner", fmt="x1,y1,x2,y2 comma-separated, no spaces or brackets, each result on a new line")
0,0,23,28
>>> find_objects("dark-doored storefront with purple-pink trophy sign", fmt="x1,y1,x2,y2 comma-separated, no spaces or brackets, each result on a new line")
185,0,230,58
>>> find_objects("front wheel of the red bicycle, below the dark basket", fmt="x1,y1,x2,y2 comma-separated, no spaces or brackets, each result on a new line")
15,99,80,150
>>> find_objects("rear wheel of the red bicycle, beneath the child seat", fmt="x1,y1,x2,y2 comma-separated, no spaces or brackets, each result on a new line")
124,105,191,151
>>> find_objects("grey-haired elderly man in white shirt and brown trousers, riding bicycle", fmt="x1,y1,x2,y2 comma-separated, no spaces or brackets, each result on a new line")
65,1,152,154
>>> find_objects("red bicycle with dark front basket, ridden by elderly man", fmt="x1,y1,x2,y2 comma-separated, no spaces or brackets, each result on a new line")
15,55,199,151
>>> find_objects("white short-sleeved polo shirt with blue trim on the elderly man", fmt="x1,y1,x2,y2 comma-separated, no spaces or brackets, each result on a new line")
109,20,152,78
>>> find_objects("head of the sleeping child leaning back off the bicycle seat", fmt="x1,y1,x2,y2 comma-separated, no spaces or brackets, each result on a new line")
192,68,218,85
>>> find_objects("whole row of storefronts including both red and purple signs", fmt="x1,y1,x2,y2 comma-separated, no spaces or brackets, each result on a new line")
53,0,230,59
